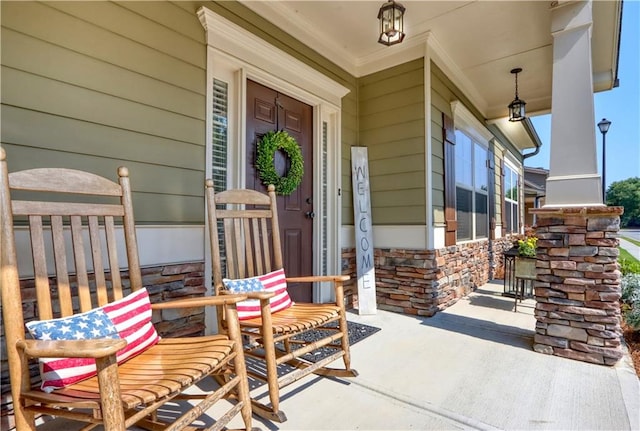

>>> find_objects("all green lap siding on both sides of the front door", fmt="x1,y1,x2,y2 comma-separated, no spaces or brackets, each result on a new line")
0,1,496,233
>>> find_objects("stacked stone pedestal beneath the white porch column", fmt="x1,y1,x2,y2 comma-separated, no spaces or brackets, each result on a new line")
531,206,623,365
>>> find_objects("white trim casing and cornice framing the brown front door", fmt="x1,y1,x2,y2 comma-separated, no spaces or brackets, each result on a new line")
197,7,350,331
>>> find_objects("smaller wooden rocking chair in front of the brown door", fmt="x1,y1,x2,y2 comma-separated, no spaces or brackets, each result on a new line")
206,180,358,422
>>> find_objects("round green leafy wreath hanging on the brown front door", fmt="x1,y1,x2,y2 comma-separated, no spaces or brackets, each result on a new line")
256,130,304,196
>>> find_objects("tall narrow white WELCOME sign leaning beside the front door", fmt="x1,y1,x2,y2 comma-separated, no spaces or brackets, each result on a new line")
351,147,377,314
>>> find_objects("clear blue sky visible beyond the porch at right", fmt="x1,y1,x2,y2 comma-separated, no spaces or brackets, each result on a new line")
525,0,640,188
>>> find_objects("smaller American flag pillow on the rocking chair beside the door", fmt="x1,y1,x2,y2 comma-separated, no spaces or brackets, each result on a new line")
222,269,292,320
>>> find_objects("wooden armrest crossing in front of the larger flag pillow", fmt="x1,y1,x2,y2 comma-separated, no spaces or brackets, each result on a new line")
16,338,127,359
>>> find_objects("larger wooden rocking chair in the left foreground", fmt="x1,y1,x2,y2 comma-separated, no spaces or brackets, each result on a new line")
0,149,251,431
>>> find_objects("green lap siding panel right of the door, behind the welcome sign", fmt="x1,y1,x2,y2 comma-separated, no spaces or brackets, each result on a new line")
358,58,426,225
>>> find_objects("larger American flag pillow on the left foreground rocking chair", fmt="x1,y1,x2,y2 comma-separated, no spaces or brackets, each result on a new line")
26,289,160,392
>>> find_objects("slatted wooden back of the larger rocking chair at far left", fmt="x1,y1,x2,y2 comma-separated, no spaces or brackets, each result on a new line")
9,178,136,319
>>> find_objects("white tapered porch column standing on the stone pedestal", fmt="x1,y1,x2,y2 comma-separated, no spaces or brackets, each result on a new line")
545,1,603,207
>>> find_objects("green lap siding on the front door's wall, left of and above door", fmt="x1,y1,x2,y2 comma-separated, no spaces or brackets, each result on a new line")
0,1,358,224
